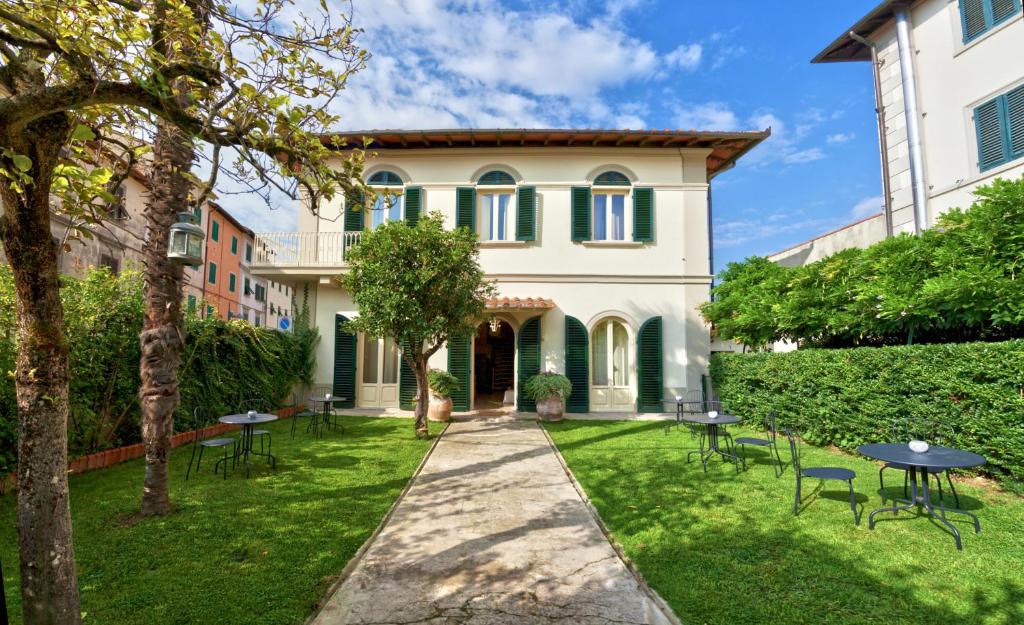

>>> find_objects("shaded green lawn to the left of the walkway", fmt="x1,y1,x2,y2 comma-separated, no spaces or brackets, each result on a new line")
0,417,440,625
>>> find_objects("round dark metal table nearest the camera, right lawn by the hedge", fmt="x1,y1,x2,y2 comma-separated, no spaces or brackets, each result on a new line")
857,443,986,549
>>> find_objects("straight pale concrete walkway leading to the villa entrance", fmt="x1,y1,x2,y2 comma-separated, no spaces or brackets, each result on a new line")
313,419,670,625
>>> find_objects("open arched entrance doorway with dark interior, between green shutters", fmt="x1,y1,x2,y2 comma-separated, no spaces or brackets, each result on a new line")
473,319,515,410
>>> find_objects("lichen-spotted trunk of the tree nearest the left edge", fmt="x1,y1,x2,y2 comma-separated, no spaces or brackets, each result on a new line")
0,109,82,625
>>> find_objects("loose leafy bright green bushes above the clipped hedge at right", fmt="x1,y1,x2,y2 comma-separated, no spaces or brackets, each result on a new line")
701,179,1024,347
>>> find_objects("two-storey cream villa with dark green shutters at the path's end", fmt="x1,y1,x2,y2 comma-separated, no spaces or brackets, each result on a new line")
252,130,768,413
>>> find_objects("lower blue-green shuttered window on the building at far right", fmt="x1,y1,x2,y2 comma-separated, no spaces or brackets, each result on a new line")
974,85,1024,171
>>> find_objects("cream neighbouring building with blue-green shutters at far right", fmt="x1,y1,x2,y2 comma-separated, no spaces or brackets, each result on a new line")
775,0,1024,262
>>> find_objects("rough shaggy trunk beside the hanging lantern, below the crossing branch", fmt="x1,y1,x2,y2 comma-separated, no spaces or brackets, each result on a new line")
139,121,195,516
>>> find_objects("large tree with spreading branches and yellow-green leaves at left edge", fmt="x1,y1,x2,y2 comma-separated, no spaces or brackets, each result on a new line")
0,0,365,625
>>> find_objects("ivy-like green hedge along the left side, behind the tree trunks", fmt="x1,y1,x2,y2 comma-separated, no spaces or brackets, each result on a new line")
0,265,319,474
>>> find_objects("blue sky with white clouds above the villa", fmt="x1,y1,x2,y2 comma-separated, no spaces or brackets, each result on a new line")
223,0,882,270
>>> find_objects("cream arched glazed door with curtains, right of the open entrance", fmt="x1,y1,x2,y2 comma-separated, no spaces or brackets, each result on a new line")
590,318,633,410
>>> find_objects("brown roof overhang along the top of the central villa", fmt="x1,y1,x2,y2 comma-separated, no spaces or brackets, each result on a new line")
322,128,771,178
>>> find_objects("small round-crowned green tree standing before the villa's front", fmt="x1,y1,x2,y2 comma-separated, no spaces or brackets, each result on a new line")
339,213,495,435
